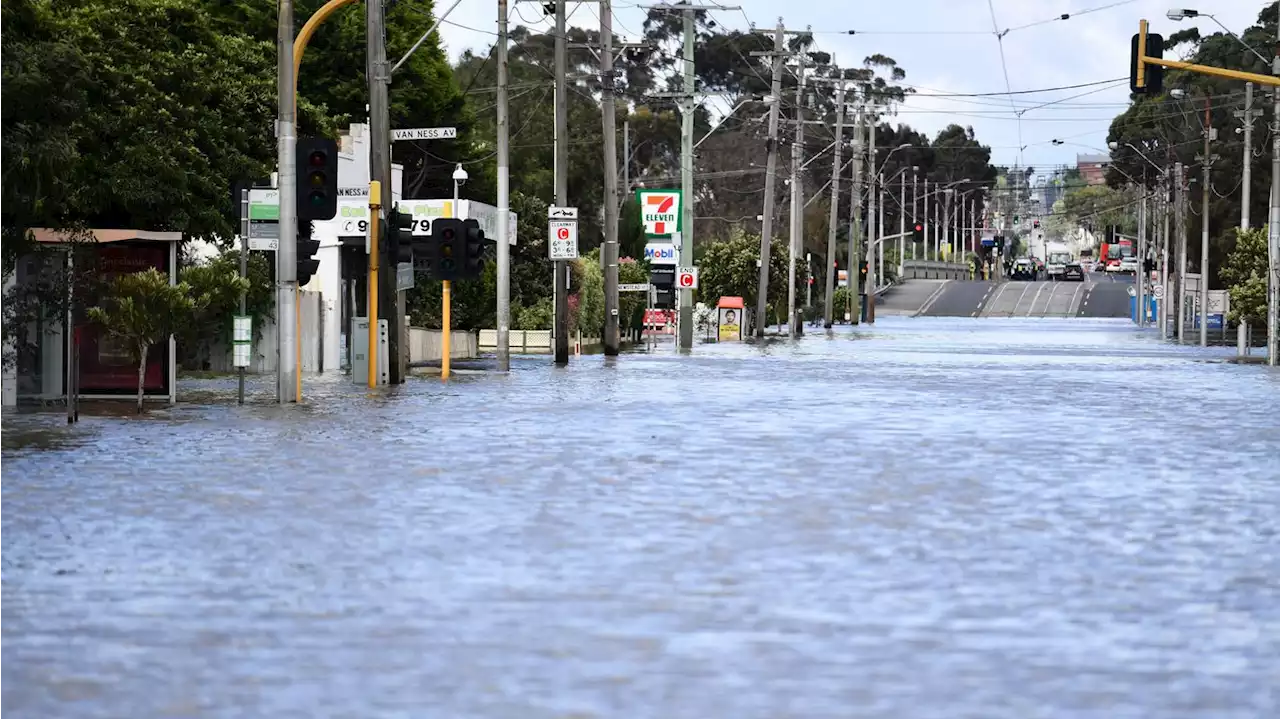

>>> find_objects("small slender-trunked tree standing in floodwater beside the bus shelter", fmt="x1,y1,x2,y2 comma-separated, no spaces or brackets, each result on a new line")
88,269,197,415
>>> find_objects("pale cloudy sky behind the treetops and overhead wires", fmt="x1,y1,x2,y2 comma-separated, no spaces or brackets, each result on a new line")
435,0,1275,170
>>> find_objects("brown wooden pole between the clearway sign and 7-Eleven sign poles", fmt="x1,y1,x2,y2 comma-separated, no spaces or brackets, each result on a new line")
600,0,619,357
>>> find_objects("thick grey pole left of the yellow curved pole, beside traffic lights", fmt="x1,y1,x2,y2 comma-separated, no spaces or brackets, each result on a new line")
273,0,298,404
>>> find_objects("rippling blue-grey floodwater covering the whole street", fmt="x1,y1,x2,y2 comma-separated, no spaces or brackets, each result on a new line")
0,317,1280,719
